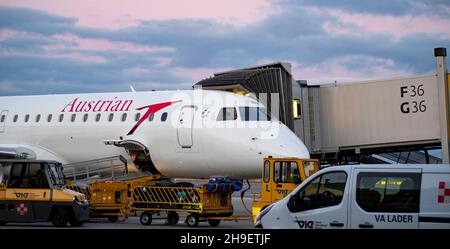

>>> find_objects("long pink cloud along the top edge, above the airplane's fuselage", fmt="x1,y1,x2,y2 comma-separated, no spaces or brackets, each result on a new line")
0,0,280,29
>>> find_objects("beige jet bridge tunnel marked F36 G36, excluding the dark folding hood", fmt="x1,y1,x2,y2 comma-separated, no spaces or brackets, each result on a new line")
293,49,449,163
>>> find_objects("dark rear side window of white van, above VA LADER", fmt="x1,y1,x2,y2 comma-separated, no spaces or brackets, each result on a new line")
356,172,421,213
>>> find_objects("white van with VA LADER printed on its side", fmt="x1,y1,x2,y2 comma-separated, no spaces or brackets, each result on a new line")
255,164,450,229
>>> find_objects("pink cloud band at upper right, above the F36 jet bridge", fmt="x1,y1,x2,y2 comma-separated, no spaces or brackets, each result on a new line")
323,9,450,38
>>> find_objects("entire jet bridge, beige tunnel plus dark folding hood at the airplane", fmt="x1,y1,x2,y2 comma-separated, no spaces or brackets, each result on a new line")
194,48,450,164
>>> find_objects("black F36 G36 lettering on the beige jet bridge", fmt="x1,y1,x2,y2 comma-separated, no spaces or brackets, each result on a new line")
400,84,427,114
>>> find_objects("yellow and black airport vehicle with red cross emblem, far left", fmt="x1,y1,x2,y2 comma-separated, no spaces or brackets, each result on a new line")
0,159,89,227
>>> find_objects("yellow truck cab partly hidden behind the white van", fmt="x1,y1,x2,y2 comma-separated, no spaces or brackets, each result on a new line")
252,157,320,218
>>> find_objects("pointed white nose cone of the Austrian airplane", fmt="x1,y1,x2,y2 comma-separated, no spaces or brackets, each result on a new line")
257,123,310,158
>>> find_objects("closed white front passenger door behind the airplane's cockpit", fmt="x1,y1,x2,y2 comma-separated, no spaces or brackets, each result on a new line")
177,105,197,148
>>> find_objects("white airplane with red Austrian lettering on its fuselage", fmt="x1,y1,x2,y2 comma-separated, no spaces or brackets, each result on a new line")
0,90,309,179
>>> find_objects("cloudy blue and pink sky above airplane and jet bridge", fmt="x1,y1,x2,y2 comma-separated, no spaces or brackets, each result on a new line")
0,0,450,96
